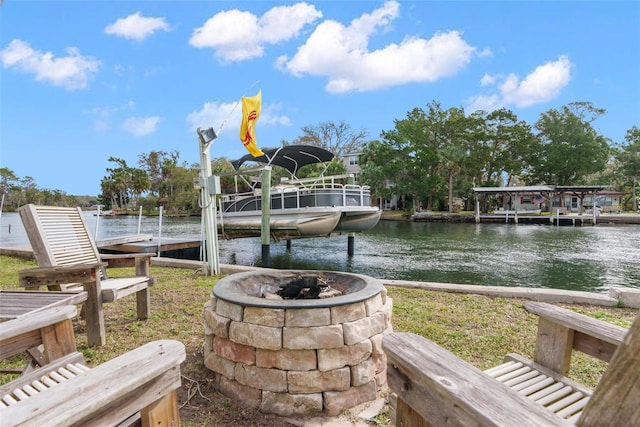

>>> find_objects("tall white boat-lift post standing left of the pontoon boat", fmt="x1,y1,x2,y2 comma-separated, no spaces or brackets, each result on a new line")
198,129,220,276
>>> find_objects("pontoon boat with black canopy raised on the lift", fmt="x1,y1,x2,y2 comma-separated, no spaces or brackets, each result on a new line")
219,145,381,239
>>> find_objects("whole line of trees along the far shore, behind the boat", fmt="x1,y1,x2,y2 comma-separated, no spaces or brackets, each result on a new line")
0,101,640,215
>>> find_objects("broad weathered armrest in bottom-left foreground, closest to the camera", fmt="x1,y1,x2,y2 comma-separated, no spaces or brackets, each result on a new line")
2,340,185,426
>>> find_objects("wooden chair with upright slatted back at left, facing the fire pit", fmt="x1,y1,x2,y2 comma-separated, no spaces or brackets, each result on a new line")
19,204,155,346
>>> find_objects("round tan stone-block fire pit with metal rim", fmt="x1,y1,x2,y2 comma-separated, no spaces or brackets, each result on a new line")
204,270,392,416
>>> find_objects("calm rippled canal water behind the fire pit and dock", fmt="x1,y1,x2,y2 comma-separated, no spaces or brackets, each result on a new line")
0,213,640,292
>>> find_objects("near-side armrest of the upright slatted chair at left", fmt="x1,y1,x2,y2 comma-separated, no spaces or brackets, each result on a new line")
18,262,106,288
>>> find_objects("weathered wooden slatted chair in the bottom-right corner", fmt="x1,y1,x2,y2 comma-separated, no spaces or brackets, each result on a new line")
383,303,640,426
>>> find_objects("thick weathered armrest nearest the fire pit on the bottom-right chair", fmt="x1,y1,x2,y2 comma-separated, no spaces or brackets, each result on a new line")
382,333,563,427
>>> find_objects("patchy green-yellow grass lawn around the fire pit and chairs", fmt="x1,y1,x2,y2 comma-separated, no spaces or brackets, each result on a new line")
0,256,638,426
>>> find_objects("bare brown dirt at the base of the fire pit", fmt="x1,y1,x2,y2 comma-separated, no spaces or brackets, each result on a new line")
178,347,388,427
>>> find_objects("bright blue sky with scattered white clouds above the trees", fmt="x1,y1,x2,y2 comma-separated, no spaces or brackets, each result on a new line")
0,0,640,195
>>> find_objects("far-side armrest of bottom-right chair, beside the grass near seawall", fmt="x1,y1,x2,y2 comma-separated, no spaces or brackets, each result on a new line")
524,302,628,347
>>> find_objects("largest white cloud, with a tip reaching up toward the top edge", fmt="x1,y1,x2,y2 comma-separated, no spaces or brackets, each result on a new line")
277,1,475,93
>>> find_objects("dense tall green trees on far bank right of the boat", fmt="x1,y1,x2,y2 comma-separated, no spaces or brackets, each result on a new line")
360,101,640,212
